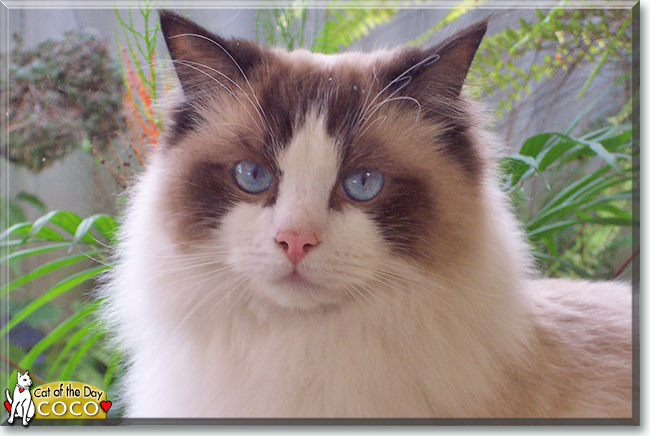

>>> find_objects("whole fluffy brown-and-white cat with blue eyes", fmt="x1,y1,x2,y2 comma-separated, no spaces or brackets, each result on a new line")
103,11,632,417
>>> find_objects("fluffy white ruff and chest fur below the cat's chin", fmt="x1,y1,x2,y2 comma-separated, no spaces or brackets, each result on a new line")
115,157,530,417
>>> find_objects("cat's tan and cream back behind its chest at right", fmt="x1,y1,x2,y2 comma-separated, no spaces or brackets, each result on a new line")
504,279,632,417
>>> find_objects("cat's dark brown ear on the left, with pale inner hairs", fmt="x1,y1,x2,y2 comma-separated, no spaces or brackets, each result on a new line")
158,10,262,97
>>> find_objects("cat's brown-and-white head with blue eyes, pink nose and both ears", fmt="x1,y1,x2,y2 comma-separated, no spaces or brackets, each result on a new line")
153,13,485,308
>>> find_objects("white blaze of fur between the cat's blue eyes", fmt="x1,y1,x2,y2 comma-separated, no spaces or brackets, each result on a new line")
275,113,339,233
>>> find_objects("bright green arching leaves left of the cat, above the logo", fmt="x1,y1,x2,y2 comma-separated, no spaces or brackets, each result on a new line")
0,211,117,396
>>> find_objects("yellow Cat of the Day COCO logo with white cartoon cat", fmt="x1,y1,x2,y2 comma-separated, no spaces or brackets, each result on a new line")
5,371,113,426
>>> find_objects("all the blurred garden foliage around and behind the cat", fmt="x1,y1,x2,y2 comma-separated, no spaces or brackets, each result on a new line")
0,0,639,416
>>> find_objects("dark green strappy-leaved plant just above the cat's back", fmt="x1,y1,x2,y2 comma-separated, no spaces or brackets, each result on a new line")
502,120,639,278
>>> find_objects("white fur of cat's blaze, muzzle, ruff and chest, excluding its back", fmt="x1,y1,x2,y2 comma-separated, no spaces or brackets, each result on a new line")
105,110,628,417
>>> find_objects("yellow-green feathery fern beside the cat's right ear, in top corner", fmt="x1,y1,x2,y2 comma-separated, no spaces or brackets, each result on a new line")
468,8,632,117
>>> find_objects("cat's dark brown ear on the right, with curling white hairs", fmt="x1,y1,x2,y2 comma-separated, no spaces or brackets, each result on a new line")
389,20,488,100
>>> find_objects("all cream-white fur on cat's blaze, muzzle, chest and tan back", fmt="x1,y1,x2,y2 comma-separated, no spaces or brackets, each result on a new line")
104,110,632,418
